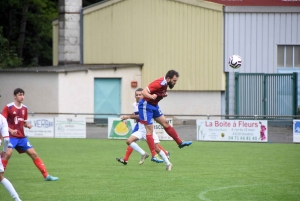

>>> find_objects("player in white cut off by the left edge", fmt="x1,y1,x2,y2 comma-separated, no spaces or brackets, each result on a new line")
0,114,21,201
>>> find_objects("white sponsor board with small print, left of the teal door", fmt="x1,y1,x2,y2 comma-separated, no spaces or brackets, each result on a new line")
55,117,86,138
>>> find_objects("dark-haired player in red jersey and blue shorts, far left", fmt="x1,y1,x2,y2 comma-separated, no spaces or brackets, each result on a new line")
2,88,58,181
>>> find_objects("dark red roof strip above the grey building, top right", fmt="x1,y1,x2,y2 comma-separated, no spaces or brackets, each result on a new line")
206,0,300,6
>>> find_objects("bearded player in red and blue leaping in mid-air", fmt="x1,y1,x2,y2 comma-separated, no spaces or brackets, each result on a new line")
139,70,192,160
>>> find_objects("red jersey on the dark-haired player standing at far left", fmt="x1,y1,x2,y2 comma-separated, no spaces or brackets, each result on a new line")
2,102,28,138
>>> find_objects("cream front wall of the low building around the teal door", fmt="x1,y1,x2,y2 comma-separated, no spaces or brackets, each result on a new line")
58,67,141,121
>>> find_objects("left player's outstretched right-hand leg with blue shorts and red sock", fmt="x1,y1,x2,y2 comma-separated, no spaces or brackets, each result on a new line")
20,138,58,181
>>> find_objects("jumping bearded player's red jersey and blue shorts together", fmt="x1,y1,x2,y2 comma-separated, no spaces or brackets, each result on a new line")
139,77,168,125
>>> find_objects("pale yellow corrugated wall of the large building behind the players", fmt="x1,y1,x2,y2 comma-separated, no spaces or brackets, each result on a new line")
83,0,225,91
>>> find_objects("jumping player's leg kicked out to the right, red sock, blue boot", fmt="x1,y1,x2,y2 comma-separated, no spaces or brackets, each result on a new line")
154,111,192,148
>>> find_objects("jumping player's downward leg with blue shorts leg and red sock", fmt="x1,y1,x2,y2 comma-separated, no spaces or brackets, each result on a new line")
139,99,156,158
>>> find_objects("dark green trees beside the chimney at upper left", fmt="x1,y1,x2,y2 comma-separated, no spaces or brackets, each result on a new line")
0,0,103,68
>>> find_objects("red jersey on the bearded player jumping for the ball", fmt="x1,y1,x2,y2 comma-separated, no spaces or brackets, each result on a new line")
144,77,168,105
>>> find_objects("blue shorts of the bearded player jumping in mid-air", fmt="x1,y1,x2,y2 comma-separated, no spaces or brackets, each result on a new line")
139,99,163,125
